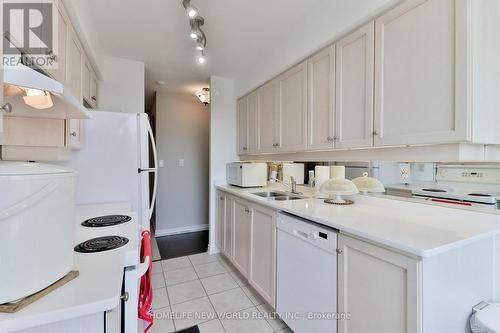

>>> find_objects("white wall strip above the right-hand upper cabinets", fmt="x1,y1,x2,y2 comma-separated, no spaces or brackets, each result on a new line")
235,0,401,97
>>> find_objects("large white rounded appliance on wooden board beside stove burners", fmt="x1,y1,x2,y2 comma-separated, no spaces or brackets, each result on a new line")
0,162,77,304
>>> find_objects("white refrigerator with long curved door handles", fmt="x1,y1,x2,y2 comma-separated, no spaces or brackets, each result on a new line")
64,111,158,230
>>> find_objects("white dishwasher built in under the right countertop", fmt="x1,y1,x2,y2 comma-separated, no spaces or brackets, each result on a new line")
276,213,337,333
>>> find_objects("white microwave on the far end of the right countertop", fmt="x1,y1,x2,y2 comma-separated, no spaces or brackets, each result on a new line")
226,162,267,187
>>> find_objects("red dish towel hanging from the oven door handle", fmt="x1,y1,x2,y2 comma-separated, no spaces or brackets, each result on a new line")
138,230,154,333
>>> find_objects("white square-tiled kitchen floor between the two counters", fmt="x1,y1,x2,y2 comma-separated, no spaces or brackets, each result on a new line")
149,253,293,333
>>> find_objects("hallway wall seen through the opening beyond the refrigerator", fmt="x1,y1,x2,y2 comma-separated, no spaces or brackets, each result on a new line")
156,93,210,236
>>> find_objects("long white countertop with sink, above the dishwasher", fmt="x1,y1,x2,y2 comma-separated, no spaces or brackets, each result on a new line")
216,185,500,257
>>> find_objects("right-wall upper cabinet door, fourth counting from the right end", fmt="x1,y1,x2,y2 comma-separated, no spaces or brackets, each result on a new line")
278,62,307,152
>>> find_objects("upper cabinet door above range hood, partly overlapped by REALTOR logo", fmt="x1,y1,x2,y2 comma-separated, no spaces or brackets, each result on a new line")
49,2,68,84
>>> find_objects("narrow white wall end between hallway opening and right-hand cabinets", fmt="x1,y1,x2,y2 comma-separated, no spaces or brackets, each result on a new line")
209,76,239,252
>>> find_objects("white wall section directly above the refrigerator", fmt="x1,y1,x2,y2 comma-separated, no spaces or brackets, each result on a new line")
97,56,145,113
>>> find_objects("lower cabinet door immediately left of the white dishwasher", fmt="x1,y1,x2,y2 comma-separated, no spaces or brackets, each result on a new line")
249,206,276,307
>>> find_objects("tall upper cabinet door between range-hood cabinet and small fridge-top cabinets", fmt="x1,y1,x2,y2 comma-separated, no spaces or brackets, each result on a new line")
66,29,83,102
